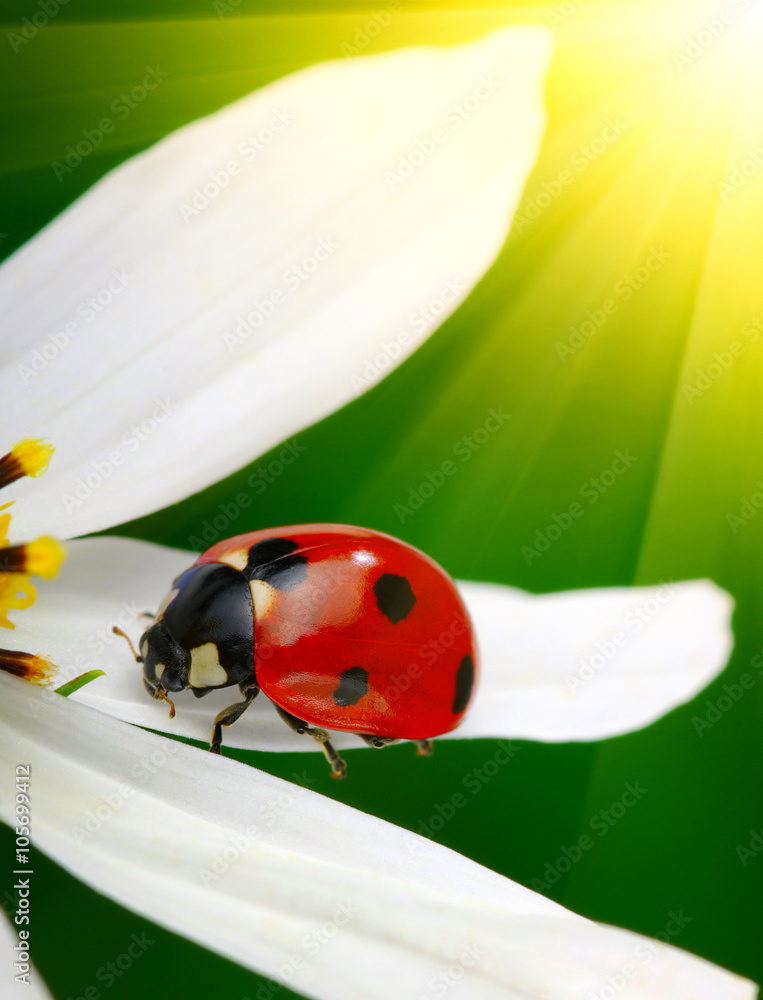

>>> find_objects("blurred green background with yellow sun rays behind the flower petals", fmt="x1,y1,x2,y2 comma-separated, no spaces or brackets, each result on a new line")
0,0,763,1000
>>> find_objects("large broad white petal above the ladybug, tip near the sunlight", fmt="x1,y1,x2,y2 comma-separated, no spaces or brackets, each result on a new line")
0,27,550,537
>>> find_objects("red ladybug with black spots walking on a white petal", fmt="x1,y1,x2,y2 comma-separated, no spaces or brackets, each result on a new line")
119,524,476,778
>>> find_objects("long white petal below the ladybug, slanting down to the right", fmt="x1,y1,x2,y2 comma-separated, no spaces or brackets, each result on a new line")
0,676,756,1000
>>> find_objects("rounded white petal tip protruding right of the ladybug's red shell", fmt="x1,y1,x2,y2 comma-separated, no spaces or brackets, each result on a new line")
452,580,734,741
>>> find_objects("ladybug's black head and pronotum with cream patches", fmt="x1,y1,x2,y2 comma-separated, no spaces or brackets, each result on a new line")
129,563,254,717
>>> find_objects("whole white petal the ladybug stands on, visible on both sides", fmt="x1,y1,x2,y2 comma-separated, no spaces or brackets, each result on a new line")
4,538,732,750
